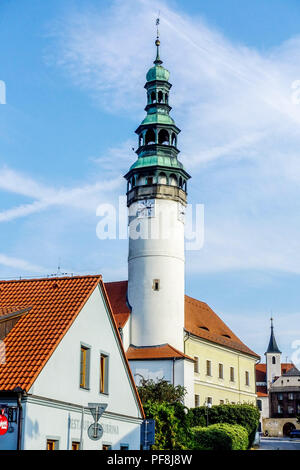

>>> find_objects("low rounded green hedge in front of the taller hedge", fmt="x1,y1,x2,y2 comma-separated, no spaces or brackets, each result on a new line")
192,423,248,451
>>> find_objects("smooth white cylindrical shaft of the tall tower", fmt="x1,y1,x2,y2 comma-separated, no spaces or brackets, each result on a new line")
128,199,184,351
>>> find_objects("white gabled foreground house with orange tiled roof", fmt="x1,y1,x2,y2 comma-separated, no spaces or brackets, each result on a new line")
0,276,144,450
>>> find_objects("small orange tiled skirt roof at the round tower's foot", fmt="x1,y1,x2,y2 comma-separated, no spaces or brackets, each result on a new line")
126,344,194,361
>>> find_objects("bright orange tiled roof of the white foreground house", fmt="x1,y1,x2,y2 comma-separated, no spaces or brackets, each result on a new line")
0,275,144,417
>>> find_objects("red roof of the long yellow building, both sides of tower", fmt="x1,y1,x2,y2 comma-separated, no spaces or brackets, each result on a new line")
105,281,260,358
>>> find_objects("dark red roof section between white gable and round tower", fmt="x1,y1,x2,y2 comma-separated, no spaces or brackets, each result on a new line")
105,281,130,328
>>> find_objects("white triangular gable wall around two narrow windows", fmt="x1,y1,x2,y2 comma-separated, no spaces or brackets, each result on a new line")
30,286,140,417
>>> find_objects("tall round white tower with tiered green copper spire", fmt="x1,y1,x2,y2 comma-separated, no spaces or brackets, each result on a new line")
125,24,190,350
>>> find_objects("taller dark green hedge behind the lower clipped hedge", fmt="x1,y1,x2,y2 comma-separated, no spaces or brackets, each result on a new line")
189,404,259,447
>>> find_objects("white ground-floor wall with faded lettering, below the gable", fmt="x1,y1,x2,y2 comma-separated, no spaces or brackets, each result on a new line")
22,402,140,450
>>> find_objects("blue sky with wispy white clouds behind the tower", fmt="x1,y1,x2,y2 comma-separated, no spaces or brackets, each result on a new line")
0,0,300,364
